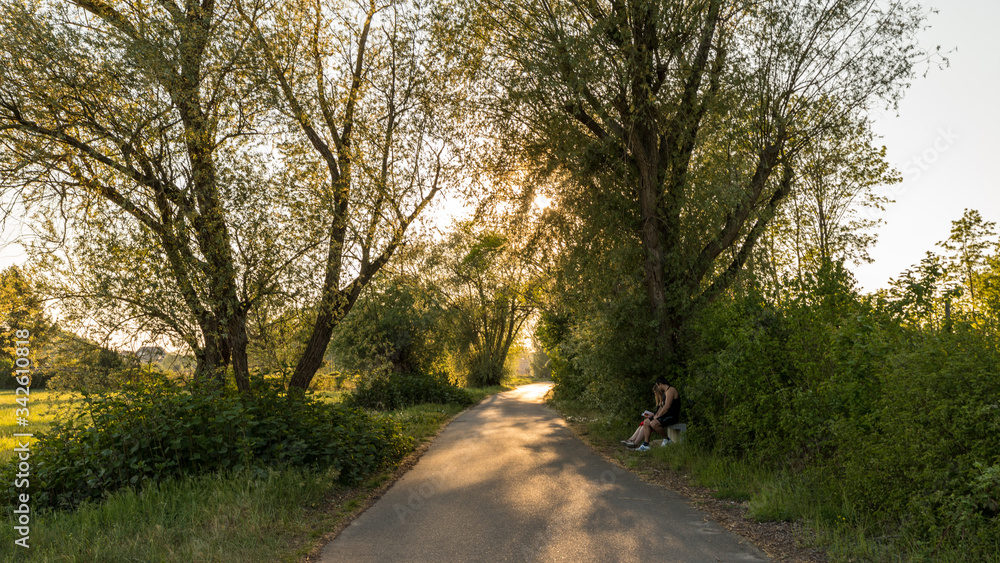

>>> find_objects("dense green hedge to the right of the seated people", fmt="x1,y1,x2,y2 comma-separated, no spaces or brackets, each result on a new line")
685,272,1000,558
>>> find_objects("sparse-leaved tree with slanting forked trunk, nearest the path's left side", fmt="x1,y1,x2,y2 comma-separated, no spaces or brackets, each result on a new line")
236,0,461,389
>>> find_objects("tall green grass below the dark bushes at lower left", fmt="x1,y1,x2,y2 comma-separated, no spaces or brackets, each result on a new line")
0,469,337,563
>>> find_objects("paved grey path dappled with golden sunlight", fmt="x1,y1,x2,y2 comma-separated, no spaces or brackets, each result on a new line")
321,384,767,563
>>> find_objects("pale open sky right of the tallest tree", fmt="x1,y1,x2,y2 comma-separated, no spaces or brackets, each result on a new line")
855,0,1000,291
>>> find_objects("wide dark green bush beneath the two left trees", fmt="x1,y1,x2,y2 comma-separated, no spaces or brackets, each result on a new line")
0,378,409,508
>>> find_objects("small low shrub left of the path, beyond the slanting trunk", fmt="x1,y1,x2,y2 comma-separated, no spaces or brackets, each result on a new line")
344,372,473,410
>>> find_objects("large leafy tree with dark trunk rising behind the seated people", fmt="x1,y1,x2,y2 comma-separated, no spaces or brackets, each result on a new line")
460,0,923,372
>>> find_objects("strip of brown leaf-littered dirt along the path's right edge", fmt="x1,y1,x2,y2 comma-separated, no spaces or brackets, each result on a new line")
568,421,829,563
